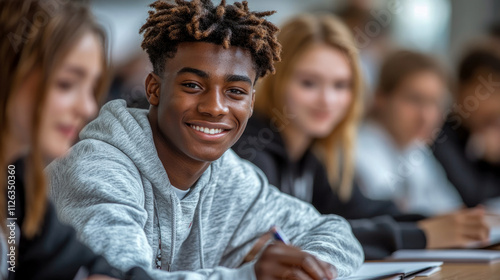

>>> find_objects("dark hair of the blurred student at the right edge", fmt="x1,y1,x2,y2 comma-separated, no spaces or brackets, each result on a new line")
458,44,500,84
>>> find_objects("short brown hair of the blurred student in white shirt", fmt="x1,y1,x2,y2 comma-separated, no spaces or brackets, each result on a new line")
377,50,448,95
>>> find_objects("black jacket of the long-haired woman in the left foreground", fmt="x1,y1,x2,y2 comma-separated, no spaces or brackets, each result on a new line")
7,160,151,280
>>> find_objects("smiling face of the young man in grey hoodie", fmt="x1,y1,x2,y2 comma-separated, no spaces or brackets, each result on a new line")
148,42,257,161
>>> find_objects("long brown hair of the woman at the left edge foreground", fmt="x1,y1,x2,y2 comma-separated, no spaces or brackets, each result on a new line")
0,0,107,237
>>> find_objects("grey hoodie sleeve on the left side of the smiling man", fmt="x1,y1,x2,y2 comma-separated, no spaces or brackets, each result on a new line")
47,142,256,280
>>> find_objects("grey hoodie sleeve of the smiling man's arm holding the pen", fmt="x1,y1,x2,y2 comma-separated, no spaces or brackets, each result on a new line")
219,155,363,277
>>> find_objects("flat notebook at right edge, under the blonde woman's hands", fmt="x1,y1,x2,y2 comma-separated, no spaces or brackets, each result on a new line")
388,249,500,263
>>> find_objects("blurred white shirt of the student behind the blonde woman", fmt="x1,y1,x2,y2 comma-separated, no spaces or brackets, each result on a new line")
356,121,463,215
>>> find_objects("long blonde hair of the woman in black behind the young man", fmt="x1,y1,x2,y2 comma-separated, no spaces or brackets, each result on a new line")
255,14,362,201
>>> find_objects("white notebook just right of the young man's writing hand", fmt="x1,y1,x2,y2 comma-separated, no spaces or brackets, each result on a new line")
337,262,443,280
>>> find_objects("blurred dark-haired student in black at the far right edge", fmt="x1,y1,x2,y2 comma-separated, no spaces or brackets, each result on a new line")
433,41,500,207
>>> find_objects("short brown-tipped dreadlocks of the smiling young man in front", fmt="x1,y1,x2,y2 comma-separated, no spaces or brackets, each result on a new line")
139,0,281,77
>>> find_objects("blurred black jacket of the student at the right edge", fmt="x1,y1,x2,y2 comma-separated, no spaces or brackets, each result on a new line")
432,117,500,207
